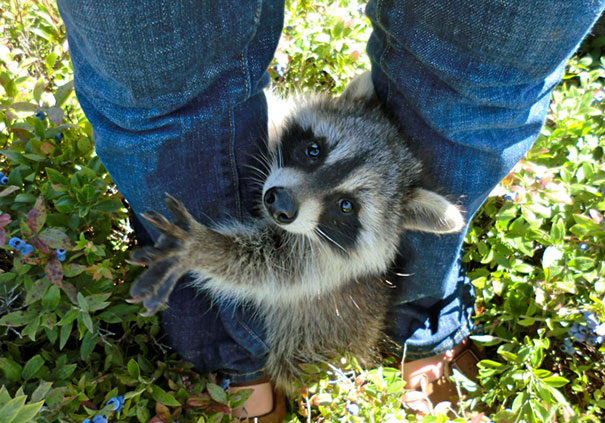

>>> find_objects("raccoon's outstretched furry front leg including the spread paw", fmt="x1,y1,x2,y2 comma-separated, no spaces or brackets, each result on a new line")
130,195,290,314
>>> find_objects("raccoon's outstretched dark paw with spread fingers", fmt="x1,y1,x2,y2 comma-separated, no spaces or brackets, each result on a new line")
128,194,200,316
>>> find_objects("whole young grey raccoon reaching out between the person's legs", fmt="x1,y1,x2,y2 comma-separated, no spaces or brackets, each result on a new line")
130,73,463,393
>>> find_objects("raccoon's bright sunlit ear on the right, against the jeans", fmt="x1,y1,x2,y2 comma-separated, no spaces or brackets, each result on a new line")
403,188,464,234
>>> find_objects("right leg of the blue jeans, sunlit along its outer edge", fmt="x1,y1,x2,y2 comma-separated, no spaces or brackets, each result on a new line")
366,0,605,358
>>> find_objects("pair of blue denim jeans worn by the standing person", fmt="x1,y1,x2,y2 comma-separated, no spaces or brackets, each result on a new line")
58,0,604,381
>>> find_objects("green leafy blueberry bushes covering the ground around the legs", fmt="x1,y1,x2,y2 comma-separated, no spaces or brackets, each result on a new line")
0,0,605,423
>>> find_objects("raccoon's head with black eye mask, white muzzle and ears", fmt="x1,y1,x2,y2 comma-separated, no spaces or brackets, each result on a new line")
262,73,463,255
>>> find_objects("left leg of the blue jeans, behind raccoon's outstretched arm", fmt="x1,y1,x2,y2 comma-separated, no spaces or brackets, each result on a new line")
58,0,284,380
